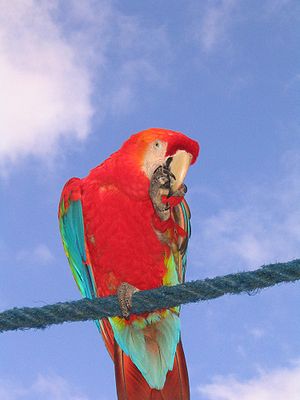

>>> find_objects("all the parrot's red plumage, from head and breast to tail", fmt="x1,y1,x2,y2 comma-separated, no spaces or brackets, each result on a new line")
60,129,199,400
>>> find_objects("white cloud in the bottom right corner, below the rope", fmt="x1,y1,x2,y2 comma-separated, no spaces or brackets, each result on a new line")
198,363,300,400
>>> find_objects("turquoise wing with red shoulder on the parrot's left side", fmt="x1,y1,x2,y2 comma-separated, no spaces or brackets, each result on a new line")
58,178,97,299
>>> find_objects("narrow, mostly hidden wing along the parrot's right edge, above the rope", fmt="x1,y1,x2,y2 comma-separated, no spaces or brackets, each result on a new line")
173,198,191,282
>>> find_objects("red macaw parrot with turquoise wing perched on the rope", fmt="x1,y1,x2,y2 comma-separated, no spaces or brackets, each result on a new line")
58,128,200,400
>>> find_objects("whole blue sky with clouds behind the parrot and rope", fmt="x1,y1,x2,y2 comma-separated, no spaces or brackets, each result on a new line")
0,0,300,400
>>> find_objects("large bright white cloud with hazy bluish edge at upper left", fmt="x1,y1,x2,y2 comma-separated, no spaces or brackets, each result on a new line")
0,0,168,172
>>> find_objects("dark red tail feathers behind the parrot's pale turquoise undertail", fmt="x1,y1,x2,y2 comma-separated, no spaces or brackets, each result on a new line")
114,341,190,400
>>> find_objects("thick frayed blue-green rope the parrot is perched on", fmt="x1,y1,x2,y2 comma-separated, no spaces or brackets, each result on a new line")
0,259,300,332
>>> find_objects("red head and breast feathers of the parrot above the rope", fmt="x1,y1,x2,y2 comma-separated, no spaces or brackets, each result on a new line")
81,129,199,296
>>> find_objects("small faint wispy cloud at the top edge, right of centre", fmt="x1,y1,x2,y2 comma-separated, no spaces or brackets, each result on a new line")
195,0,236,52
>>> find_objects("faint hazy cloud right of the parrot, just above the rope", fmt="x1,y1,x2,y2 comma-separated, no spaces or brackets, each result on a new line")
191,153,300,275
